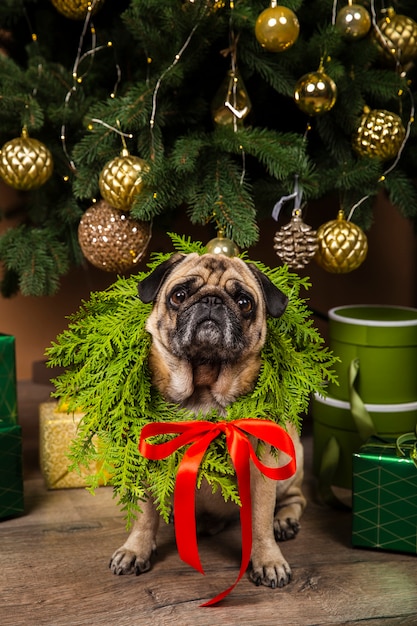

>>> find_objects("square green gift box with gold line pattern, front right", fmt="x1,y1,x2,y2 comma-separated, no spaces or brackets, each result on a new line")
352,437,417,554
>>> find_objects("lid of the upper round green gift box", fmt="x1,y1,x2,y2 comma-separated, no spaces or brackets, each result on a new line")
329,305,417,347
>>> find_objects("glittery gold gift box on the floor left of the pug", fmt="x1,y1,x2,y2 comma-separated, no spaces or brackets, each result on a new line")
39,402,101,489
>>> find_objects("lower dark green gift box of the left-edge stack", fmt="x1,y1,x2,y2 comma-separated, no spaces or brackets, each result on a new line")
0,424,24,518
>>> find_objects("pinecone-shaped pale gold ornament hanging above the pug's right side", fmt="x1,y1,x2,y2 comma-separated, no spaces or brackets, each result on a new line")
274,209,318,269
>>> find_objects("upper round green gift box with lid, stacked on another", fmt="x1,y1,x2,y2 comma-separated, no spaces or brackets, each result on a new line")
328,305,417,404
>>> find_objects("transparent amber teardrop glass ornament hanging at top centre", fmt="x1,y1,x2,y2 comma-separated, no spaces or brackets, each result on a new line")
211,70,252,126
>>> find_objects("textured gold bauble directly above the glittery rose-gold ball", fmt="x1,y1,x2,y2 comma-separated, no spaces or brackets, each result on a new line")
99,150,149,211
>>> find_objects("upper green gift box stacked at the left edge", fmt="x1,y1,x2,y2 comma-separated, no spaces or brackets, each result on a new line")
0,334,17,428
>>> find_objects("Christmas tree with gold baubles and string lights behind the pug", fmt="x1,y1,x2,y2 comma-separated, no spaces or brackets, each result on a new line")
0,0,417,296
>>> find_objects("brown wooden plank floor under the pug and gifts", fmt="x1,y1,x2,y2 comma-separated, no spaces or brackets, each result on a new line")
0,383,417,626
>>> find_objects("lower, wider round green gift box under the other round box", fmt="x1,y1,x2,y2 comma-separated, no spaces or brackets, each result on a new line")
311,394,417,489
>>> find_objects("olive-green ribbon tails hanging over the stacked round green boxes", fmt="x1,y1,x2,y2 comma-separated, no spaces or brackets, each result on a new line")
319,359,377,509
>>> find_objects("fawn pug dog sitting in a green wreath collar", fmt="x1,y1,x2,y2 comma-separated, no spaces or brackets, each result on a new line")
110,253,306,588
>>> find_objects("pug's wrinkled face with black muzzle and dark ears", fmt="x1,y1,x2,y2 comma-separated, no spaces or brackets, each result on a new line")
138,254,287,364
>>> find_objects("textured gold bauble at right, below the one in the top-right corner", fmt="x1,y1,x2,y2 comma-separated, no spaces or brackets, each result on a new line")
353,107,406,161
